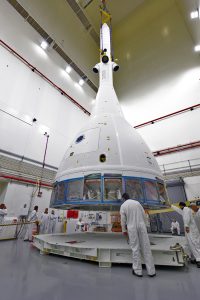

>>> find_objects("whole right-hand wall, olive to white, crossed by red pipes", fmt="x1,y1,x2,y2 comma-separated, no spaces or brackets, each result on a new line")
113,0,200,169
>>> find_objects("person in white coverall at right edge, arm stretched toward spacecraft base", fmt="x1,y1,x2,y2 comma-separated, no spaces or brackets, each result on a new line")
171,202,200,268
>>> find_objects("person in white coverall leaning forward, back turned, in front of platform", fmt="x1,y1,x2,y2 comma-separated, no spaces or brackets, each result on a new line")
120,193,156,277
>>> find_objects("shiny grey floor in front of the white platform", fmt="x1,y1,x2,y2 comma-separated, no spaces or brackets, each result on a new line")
0,240,200,300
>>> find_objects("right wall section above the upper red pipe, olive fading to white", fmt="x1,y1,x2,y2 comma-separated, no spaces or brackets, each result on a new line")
114,0,200,118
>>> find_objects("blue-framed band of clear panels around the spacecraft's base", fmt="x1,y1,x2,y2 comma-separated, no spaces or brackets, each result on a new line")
51,174,167,208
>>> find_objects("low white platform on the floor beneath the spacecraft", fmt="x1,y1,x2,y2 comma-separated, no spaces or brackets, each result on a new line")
33,232,187,267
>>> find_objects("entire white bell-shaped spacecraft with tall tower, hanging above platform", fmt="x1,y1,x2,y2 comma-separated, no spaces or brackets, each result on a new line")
51,23,167,210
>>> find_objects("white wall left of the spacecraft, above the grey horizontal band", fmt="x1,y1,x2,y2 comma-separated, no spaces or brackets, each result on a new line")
0,1,95,166
